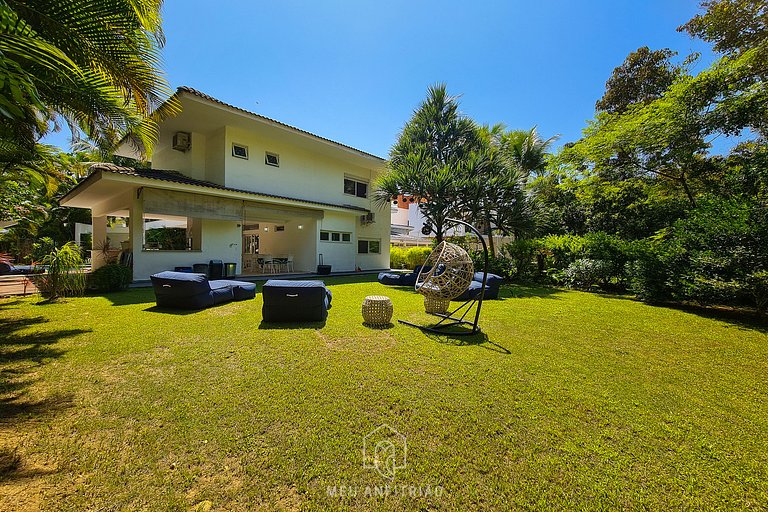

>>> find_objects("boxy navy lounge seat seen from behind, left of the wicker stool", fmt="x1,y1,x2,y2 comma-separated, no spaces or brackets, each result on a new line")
261,279,332,322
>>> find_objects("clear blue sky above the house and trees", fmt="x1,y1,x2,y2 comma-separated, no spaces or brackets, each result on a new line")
49,0,712,157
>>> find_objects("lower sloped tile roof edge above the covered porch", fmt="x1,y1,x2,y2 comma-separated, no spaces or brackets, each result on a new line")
61,163,368,212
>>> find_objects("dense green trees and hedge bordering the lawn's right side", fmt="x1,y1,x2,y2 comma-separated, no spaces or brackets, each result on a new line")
502,0,768,311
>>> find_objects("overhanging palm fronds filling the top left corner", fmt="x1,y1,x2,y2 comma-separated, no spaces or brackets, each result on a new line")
0,0,178,170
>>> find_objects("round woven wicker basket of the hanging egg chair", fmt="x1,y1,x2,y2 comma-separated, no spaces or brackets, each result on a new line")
416,241,475,300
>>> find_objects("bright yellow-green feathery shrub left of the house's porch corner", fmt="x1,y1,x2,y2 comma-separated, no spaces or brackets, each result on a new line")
30,242,86,300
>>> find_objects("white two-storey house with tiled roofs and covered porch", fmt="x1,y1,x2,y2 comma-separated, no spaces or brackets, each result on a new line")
61,87,390,280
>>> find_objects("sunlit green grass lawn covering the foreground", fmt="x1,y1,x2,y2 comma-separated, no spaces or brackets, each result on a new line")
0,278,768,510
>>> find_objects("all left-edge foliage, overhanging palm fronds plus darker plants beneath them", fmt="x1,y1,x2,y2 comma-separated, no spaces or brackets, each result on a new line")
0,0,178,261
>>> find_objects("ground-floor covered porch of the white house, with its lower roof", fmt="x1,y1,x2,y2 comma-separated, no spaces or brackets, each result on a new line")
59,166,368,281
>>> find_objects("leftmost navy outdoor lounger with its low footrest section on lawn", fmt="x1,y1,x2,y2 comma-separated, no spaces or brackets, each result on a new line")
150,271,256,309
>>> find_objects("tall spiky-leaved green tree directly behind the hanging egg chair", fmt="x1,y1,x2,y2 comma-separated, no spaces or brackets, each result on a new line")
374,84,480,242
